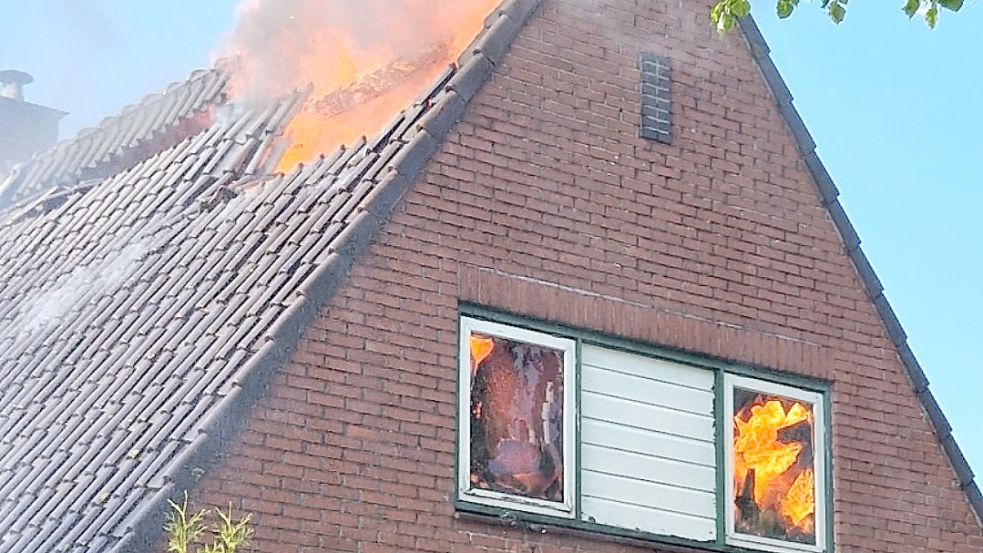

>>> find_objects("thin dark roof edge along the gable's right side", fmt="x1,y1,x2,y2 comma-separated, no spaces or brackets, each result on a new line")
740,16,983,525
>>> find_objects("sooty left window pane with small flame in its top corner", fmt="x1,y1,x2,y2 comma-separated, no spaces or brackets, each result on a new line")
470,334,564,502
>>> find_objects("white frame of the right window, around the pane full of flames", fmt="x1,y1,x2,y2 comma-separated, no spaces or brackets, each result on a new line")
722,373,828,553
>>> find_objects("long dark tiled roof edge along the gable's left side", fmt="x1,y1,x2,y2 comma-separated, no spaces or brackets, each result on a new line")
112,0,542,553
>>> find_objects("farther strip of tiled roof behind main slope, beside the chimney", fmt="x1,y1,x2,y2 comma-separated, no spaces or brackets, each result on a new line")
0,69,228,209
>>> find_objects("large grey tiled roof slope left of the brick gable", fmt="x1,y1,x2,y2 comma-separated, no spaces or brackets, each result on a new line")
0,0,539,553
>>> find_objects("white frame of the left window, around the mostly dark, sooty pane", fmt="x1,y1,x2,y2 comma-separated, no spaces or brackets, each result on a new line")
457,316,577,519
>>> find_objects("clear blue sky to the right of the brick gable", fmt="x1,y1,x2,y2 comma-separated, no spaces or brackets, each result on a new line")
755,0,983,481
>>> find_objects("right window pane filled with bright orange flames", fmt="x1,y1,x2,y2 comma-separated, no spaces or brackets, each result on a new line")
734,389,816,544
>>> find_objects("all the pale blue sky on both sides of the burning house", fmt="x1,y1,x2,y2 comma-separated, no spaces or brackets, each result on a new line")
0,0,983,481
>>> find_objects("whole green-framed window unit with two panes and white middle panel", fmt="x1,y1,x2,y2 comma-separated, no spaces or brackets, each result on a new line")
457,310,831,553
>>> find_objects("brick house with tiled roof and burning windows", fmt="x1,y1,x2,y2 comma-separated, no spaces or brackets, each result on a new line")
0,0,983,553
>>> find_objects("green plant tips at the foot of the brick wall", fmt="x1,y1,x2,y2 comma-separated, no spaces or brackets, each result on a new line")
164,492,253,553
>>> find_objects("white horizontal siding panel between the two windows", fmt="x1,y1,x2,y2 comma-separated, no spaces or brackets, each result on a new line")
580,345,716,541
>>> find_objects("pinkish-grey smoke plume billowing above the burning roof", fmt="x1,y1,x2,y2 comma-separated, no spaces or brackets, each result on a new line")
220,0,497,103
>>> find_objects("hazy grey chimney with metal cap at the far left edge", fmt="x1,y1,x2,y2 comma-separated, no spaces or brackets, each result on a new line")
0,69,66,165
